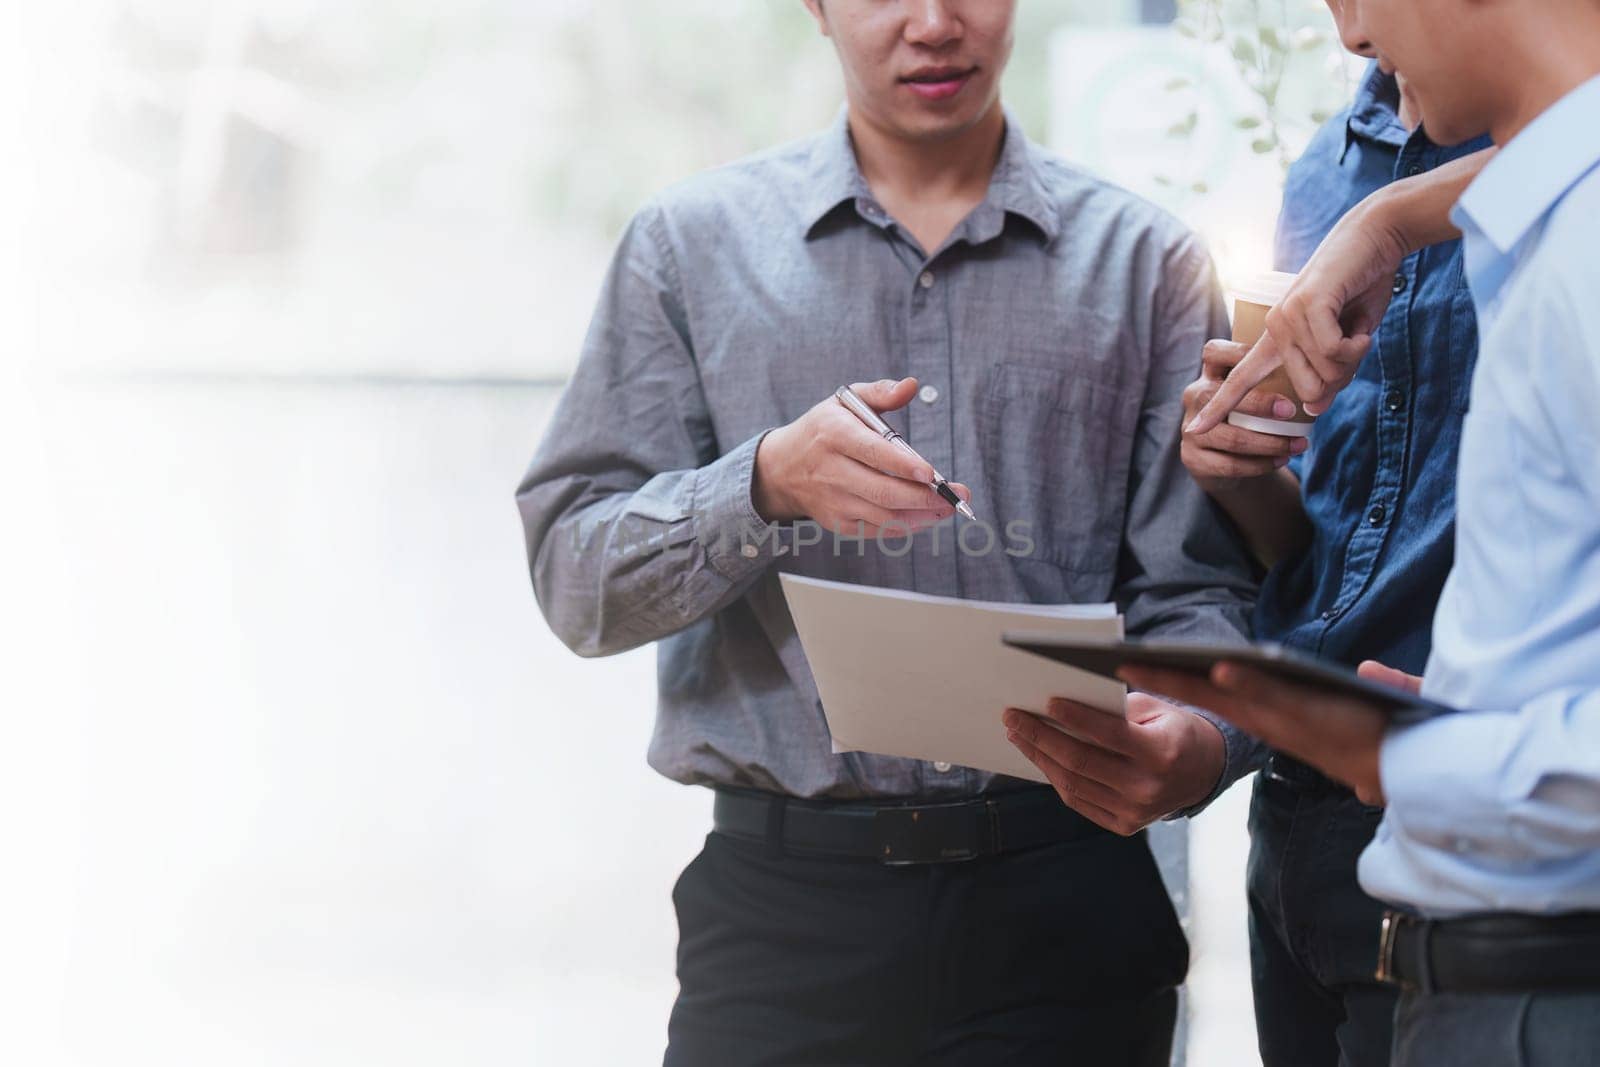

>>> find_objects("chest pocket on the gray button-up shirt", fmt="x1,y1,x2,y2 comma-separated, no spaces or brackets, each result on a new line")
981,362,1139,595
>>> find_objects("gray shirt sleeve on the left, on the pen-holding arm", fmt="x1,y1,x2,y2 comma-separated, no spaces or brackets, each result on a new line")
517,205,781,656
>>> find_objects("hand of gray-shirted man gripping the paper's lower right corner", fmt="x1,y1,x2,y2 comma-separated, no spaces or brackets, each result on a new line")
1003,693,1227,837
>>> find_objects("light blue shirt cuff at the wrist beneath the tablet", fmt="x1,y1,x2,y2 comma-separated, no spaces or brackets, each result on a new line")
1378,712,1517,848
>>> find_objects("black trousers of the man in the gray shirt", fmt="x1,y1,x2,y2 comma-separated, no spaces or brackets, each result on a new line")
666,833,1189,1067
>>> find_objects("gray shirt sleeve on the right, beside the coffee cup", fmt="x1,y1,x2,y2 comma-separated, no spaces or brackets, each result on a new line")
1117,237,1266,816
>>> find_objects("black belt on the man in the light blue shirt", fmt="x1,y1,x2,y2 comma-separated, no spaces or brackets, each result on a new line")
1378,912,1600,993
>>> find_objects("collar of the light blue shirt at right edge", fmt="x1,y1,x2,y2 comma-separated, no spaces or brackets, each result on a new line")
1451,77,1600,256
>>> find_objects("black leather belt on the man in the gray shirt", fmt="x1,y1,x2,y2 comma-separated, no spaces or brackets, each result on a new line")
712,787,1109,865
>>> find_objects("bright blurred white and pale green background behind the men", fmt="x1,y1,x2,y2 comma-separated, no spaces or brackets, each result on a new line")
12,0,1358,1065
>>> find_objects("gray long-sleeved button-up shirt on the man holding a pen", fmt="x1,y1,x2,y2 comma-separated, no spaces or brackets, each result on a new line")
517,117,1254,797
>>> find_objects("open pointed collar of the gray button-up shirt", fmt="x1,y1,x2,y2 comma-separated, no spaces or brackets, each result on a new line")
802,109,1061,242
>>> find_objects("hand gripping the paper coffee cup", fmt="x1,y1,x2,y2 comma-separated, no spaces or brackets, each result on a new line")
1181,341,1309,494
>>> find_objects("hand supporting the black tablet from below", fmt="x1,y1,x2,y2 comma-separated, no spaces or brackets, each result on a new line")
1117,661,1422,805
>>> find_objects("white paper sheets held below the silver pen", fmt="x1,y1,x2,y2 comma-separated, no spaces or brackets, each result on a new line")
781,574,1126,782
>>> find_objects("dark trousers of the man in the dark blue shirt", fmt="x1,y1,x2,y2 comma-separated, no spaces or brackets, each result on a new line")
1248,757,1397,1067
